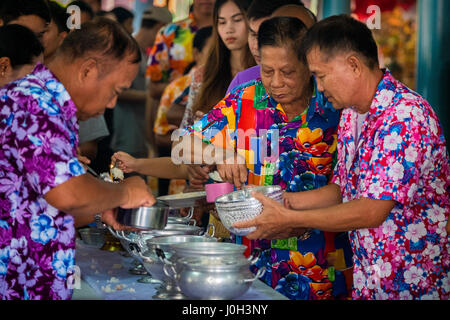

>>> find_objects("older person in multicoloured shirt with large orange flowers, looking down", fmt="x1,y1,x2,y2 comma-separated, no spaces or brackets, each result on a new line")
176,17,351,299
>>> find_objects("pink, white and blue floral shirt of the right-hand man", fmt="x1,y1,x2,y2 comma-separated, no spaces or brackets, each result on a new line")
333,71,450,299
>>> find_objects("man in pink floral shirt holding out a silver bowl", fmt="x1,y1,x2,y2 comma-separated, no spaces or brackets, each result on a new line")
235,15,450,300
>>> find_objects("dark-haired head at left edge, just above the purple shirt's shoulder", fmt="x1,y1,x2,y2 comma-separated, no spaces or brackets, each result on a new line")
0,24,44,87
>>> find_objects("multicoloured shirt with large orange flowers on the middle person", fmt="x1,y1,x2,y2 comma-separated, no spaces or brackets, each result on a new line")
187,80,351,299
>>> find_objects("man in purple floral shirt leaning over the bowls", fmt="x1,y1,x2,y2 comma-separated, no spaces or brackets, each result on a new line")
0,19,155,299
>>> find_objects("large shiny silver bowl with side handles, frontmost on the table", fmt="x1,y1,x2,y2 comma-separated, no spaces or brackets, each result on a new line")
164,242,265,300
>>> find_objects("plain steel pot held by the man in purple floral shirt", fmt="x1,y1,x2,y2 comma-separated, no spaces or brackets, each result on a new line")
117,201,170,230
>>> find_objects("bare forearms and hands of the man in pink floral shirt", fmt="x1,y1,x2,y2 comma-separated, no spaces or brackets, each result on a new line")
235,188,395,239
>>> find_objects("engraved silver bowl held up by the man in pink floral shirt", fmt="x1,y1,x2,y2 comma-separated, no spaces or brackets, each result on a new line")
216,186,283,236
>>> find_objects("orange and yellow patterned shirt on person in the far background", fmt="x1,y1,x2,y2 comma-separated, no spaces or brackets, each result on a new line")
147,14,198,83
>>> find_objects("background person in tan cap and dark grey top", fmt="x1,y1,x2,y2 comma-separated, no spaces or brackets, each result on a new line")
111,7,172,178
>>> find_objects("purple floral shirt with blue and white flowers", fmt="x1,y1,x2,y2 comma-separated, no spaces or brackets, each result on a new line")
0,64,85,299
